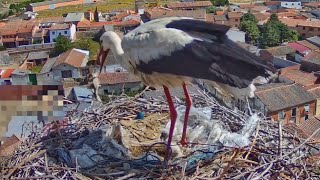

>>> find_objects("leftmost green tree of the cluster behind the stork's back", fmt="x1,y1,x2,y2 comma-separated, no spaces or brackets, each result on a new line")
239,20,260,44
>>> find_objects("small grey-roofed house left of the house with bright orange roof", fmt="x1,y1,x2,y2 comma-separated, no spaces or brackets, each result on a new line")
26,51,49,70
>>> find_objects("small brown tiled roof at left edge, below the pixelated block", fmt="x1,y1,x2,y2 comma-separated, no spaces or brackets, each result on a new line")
0,135,22,157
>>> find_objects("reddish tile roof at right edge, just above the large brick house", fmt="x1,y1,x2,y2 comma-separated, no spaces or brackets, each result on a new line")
280,65,320,89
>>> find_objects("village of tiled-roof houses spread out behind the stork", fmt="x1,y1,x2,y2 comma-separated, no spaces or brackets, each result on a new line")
0,0,320,152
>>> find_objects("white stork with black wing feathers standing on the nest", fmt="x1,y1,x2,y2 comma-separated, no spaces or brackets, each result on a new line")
96,17,275,160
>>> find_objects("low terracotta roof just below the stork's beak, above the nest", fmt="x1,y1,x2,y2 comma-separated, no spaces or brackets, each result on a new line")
98,72,141,85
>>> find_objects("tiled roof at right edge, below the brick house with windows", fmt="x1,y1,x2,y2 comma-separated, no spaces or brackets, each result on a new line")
298,116,320,141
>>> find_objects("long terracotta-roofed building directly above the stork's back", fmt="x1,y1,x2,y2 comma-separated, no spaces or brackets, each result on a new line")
144,8,206,21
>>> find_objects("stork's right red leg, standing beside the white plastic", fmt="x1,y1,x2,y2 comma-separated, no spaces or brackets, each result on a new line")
180,83,192,146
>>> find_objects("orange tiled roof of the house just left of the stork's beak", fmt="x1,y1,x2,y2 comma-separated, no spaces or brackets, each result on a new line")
53,49,86,68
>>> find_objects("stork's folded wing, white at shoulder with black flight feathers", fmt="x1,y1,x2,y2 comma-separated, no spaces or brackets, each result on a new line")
122,18,271,88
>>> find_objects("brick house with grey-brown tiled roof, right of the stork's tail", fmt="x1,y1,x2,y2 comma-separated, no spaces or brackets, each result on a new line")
250,83,316,124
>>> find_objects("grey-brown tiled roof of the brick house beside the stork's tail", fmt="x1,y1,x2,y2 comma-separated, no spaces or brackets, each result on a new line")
255,83,316,112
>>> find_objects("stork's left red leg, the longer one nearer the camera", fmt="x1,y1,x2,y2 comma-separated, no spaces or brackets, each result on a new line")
163,86,177,162
